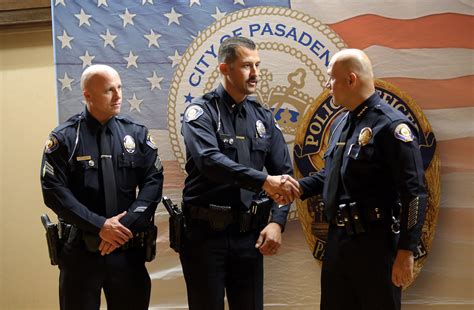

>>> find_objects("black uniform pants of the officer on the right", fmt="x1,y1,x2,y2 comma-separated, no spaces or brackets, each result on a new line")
321,222,401,310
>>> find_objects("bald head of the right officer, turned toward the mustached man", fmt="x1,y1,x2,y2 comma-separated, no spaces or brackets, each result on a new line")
327,49,375,111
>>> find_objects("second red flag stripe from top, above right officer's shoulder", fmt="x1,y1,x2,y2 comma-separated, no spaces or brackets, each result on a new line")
383,75,474,110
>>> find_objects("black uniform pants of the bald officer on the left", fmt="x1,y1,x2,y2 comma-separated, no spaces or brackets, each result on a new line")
59,241,151,310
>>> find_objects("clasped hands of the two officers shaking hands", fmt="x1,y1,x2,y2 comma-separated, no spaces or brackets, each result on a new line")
262,174,301,205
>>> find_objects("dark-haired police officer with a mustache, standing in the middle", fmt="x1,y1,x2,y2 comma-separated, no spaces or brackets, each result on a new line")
180,37,299,310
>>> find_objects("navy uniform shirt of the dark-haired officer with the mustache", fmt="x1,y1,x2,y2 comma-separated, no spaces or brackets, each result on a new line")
182,85,293,227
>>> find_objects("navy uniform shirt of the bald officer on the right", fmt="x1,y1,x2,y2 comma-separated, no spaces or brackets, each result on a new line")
299,93,427,252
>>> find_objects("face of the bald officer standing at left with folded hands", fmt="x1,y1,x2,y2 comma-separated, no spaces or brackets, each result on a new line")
84,71,122,123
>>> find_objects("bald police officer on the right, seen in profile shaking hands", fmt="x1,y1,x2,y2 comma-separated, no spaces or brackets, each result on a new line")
280,49,427,310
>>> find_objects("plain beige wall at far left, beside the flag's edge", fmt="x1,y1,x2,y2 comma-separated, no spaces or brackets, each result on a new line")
0,28,59,309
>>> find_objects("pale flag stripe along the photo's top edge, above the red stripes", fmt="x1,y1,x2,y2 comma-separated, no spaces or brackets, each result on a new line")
291,0,474,24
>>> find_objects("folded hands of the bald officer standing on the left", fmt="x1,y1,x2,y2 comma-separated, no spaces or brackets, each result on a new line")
99,211,133,255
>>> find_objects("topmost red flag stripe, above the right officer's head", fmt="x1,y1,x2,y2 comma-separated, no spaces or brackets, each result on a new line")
329,13,474,49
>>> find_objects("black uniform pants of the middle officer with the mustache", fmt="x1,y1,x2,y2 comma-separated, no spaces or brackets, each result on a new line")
180,220,263,310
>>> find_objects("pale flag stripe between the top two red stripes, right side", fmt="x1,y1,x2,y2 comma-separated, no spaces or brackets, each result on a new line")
364,46,474,80
